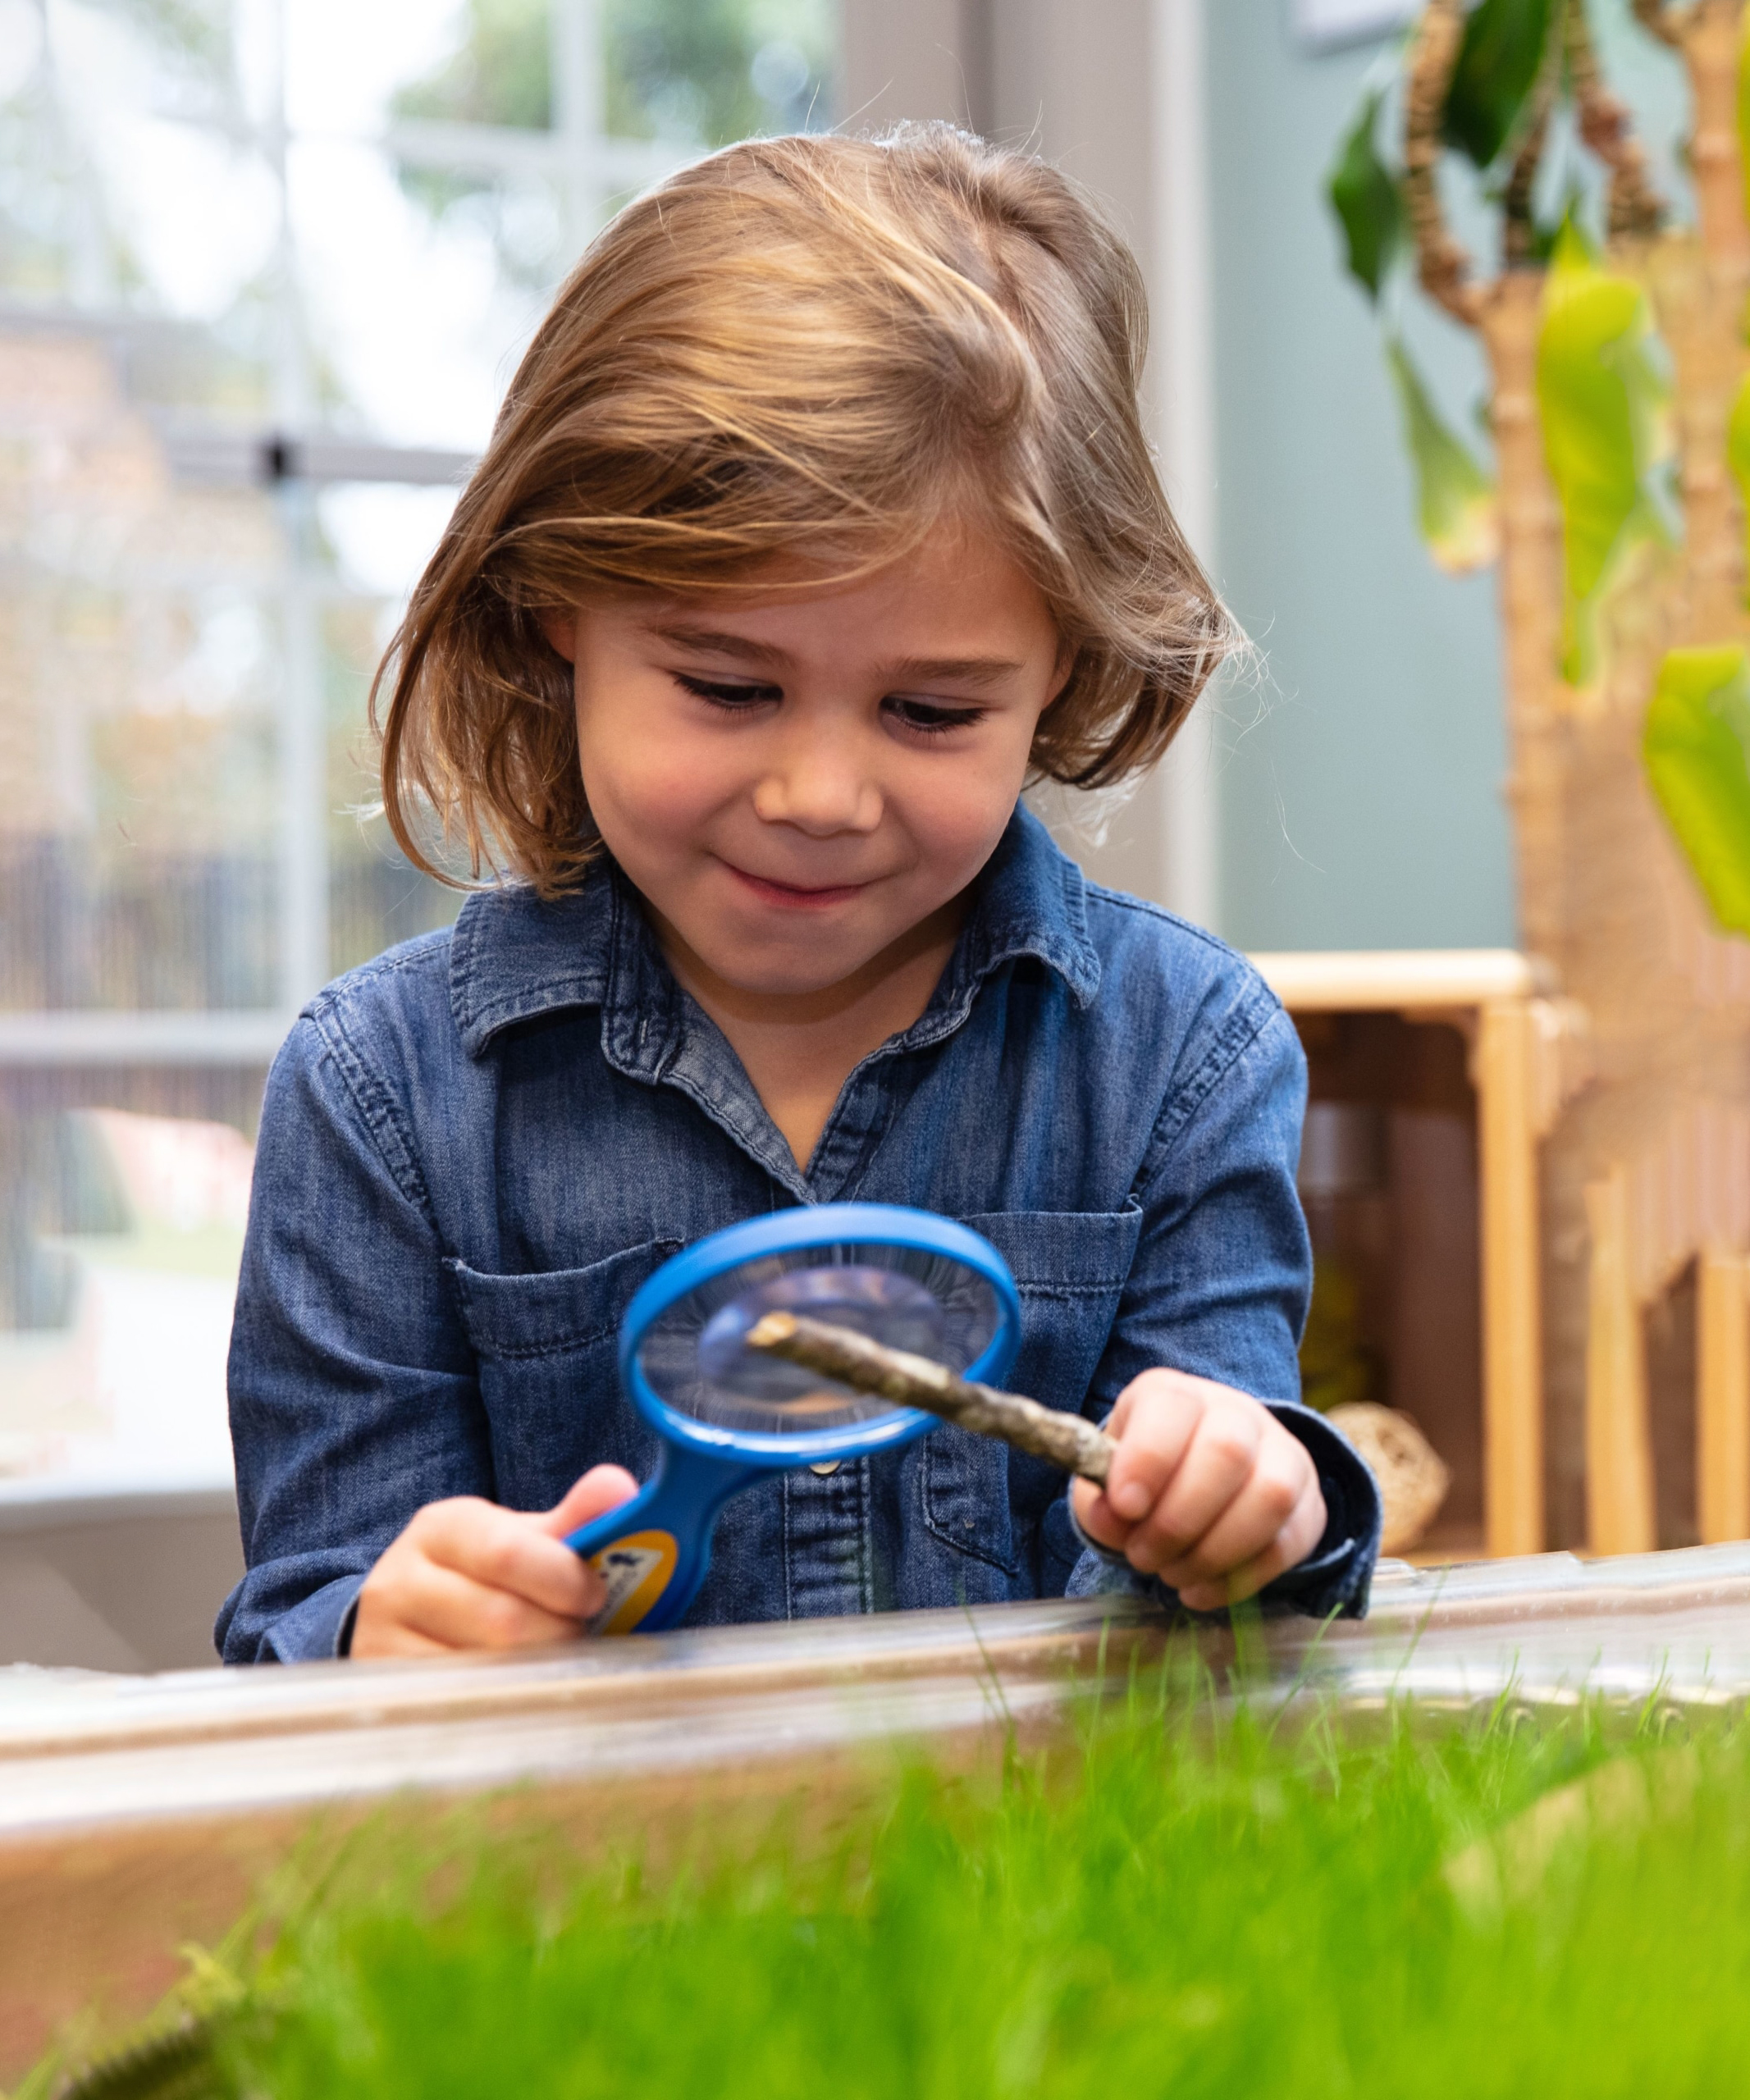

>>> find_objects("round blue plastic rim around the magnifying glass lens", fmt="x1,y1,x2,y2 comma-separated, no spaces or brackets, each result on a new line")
619,1203,1021,1470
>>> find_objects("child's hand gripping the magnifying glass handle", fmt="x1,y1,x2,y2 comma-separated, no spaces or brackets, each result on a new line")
349,1466,638,1661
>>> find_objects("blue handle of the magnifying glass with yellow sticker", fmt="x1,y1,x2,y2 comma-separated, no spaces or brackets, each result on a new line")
565,1445,765,1634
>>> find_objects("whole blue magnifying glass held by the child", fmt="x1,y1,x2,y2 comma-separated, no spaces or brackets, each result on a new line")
565,1203,1021,1634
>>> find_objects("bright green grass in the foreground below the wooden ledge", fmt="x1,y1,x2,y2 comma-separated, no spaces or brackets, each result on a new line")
25,1701,1750,2100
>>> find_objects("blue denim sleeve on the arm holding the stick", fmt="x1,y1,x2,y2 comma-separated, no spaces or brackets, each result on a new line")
1050,981,1380,1619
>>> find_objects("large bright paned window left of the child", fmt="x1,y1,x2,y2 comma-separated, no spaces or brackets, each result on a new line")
0,0,832,1497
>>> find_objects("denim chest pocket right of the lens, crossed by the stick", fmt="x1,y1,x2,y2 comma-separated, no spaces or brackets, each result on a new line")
921,1208,1143,1575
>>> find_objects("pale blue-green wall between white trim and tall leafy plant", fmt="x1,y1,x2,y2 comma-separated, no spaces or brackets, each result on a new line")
1206,0,1513,949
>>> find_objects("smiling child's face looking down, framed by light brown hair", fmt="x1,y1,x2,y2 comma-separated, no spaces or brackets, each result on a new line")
548,512,1069,995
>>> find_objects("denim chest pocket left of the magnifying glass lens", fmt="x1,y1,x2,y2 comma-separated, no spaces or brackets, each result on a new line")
450,1239,681,1510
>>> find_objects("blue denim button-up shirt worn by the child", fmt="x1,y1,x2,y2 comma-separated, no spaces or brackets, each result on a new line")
218,810,1380,1661
